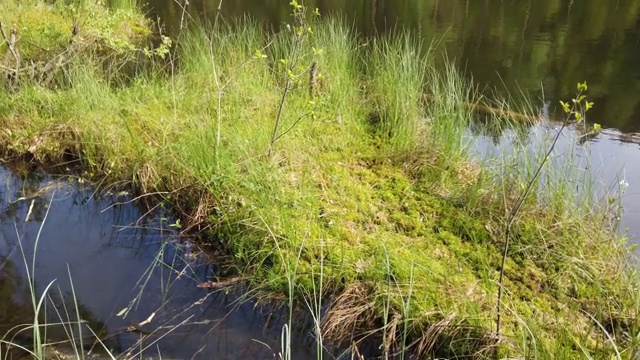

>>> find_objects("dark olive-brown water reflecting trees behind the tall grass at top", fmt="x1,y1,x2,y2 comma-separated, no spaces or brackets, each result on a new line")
150,0,640,131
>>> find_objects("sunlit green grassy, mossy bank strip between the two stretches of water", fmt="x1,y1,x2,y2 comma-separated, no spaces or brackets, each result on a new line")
0,1,640,359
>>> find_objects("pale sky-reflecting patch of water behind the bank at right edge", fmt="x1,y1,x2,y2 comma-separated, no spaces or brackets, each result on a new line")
468,123,640,245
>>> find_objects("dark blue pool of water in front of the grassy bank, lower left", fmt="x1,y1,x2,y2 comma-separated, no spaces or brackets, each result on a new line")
0,167,314,359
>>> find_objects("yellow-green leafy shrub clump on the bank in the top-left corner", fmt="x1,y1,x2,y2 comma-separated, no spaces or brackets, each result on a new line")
0,1,151,87
